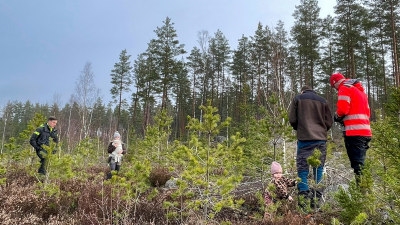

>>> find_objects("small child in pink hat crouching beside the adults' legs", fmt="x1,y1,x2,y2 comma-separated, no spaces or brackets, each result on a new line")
264,161,297,220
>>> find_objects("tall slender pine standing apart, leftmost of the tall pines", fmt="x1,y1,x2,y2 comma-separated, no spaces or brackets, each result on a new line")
111,49,133,129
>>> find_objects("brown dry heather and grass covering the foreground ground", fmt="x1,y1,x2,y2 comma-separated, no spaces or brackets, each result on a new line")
0,163,344,225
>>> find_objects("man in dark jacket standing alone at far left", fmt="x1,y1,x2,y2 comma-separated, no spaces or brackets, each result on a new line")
29,116,58,175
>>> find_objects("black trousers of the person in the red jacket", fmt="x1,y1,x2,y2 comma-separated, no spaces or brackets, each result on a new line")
344,136,371,176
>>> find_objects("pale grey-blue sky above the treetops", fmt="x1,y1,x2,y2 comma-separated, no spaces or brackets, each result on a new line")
0,0,336,108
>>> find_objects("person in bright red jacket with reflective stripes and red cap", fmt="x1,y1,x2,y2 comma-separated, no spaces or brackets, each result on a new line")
329,72,372,183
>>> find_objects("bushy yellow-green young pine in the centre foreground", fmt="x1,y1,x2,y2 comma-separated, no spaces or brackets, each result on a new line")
169,101,245,220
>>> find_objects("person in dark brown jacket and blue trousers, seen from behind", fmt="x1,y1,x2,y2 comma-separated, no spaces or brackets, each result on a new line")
289,86,333,207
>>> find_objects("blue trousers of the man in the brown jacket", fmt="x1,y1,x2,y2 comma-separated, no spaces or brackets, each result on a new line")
296,140,326,192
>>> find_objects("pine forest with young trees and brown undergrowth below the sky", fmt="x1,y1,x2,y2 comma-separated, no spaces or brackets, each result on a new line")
0,0,400,224
